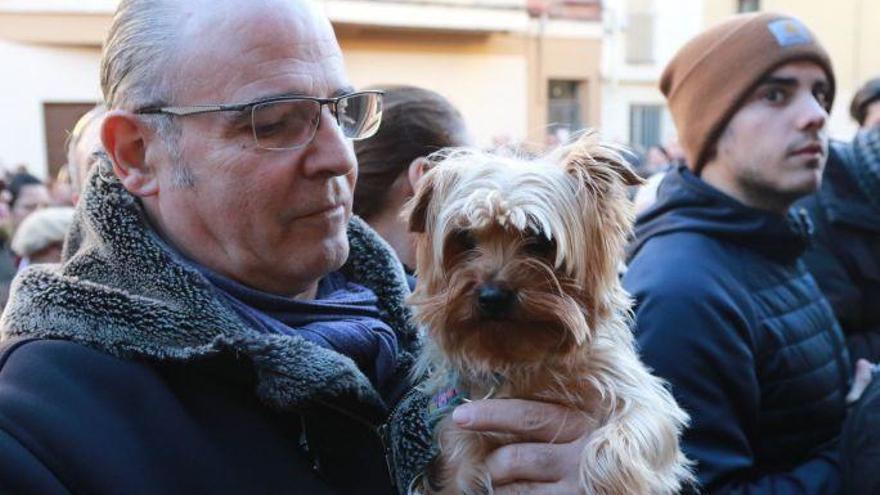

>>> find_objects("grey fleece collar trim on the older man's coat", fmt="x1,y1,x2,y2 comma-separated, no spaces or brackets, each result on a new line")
0,169,416,413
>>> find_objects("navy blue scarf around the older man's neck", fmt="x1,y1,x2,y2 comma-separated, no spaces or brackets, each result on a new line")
199,263,397,391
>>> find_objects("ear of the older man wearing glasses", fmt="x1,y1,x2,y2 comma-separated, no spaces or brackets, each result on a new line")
101,110,159,197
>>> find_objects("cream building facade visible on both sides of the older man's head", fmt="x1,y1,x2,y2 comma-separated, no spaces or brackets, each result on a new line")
0,0,603,177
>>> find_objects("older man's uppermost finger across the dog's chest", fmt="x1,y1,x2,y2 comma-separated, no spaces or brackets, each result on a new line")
452,399,590,443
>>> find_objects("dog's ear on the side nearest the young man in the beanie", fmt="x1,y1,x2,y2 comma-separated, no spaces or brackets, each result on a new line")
562,132,645,186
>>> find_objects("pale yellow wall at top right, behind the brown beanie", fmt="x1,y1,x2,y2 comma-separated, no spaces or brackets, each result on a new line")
705,0,880,139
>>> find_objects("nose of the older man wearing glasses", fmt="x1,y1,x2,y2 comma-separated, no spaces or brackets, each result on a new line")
303,106,356,177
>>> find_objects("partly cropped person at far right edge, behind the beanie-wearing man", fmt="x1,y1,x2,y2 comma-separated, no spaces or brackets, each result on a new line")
794,79,880,362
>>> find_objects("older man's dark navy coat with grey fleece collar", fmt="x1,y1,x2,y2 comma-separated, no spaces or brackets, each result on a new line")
0,171,429,494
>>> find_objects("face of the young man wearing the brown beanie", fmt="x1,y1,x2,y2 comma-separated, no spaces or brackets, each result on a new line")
703,62,830,213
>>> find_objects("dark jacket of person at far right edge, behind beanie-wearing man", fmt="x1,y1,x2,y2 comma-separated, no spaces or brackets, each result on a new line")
795,143,880,362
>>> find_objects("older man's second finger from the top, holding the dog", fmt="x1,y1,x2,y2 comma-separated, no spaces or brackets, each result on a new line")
486,443,577,486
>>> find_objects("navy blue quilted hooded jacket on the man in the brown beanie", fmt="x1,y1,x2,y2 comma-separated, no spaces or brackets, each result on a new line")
624,168,850,494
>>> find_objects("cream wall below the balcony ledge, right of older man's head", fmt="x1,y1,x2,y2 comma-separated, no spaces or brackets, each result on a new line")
337,26,602,145
